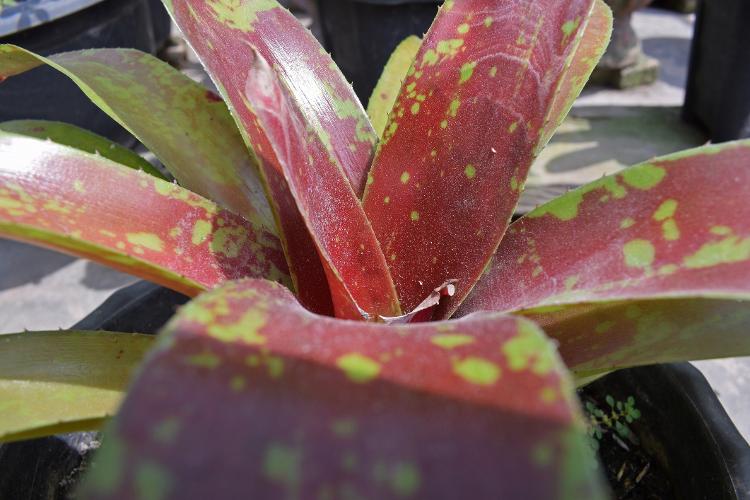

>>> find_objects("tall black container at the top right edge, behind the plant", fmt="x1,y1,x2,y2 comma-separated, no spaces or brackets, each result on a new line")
683,0,750,142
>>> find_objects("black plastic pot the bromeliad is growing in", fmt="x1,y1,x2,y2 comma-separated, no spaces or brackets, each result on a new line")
0,282,750,500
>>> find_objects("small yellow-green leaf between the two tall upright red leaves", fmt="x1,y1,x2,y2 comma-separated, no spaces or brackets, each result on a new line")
367,35,422,137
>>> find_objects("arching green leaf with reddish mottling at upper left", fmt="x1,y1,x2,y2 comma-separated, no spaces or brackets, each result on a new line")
0,45,276,233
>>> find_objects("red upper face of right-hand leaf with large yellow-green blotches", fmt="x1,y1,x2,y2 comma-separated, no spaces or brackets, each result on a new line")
460,141,750,314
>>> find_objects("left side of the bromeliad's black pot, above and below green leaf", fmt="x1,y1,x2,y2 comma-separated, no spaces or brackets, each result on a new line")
0,281,188,500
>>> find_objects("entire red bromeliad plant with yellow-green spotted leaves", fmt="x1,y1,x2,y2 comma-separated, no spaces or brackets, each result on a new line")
0,0,750,498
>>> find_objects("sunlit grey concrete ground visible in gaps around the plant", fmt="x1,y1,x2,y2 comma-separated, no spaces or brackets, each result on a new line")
0,9,750,440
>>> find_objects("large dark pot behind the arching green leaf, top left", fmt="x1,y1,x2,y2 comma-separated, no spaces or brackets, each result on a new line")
0,0,169,146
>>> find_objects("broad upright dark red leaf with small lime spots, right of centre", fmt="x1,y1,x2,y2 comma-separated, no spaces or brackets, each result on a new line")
365,0,612,317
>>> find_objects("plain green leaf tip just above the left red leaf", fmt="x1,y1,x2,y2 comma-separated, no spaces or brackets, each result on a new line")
0,120,165,179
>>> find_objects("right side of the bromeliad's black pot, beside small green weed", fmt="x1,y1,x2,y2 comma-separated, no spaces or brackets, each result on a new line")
583,363,750,500
